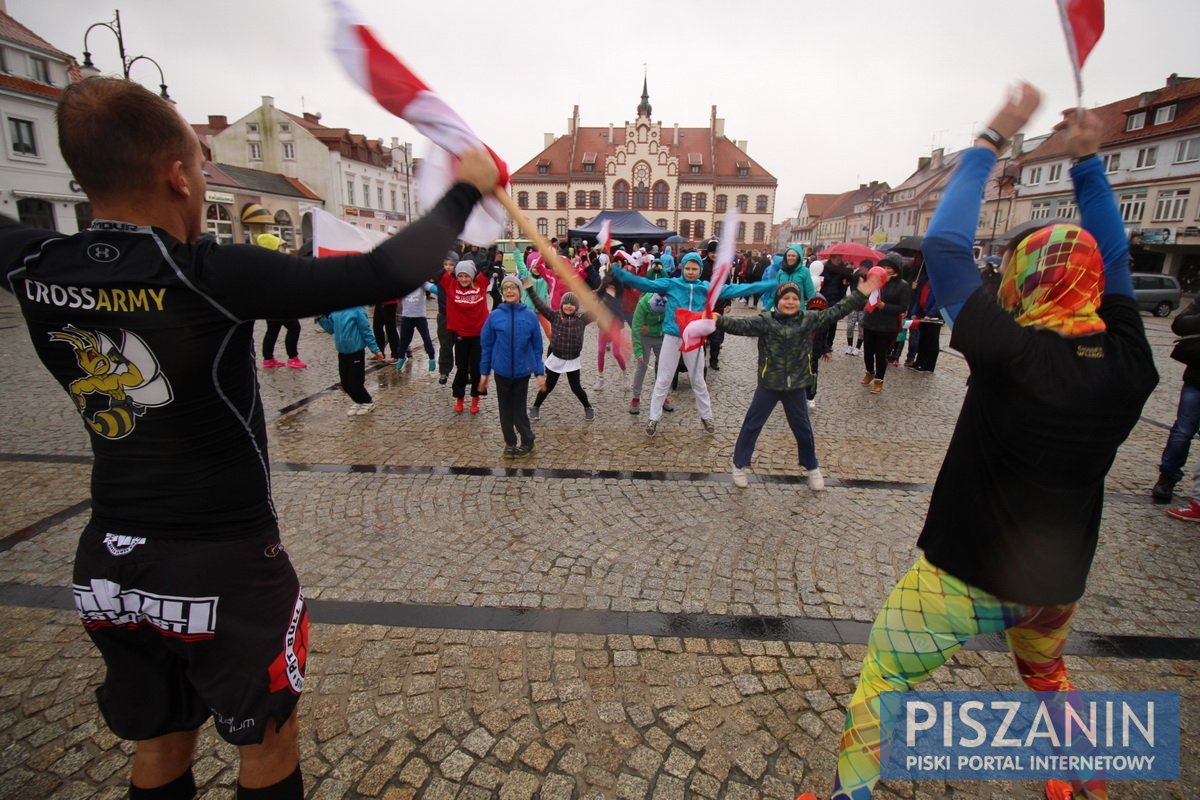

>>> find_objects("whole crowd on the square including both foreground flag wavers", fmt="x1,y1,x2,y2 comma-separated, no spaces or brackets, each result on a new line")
0,70,1180,800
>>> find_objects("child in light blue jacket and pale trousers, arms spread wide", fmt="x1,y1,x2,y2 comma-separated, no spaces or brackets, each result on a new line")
611,253,775,437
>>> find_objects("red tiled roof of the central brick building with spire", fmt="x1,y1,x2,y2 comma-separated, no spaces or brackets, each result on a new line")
512,119,775,184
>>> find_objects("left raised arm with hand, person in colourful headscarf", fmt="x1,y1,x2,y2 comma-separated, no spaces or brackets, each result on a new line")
922,84,1042,325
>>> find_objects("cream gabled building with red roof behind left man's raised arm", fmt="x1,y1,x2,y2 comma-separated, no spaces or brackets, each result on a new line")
199,96,414,230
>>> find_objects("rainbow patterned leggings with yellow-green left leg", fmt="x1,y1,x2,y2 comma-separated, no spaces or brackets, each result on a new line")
830,557,1108,800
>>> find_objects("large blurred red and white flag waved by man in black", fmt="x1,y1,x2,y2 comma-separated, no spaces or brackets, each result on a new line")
330,0,509,247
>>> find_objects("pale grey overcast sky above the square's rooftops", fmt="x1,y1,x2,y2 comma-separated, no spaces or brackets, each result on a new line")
7,0,1200,221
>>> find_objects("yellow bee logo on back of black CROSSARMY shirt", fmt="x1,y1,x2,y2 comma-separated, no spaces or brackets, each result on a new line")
50,325,173,439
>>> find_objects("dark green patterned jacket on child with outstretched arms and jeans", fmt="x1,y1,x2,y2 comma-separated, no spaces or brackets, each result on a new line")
716,291,866,392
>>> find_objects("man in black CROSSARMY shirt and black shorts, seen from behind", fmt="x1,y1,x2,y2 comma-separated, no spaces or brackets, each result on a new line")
0,78,498,800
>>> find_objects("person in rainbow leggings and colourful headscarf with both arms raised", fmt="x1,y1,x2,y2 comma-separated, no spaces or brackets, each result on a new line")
800,85,1158,800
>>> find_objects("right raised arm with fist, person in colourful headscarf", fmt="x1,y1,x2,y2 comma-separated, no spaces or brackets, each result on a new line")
1055,108,1133,297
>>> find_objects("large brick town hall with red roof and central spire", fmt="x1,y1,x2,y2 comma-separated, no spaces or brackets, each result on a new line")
512,84,778,248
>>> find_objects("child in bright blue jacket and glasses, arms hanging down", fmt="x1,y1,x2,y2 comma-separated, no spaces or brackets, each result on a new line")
479,275,546,458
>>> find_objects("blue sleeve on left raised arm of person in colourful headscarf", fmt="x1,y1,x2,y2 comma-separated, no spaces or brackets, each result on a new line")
922,148,996,326
